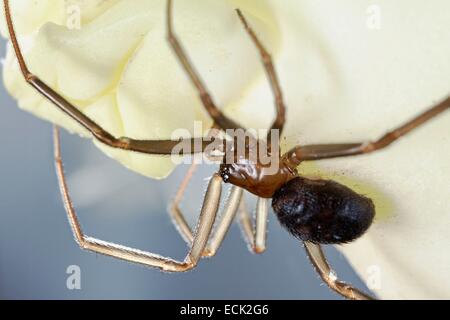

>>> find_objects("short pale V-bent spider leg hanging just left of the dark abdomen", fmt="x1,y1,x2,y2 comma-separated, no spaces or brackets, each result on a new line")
238,197,269,253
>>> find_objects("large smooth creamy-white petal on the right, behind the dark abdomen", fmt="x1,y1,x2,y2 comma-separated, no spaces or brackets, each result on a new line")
241,0,450,299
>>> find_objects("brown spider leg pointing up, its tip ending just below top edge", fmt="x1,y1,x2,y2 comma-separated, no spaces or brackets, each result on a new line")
236,9,286,135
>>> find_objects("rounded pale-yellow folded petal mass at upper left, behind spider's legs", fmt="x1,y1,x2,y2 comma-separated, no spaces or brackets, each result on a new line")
4,0,279,178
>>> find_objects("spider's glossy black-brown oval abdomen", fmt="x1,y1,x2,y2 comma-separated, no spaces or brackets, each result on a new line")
272,177,375,244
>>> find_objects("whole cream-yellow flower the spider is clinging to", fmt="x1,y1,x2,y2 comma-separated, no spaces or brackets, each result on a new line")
4,0,450,299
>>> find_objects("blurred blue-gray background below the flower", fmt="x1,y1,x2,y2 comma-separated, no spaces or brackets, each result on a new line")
0,37,367,299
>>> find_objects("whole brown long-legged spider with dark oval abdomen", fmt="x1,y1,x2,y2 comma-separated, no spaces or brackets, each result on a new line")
3,0,450,299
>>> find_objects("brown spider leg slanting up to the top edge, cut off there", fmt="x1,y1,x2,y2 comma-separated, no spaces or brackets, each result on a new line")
167,0,242,130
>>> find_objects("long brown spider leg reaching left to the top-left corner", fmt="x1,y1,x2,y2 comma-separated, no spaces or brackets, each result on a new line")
3,0,211,155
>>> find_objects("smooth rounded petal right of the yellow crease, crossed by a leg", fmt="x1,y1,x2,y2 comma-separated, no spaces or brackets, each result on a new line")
111,1,274,177
